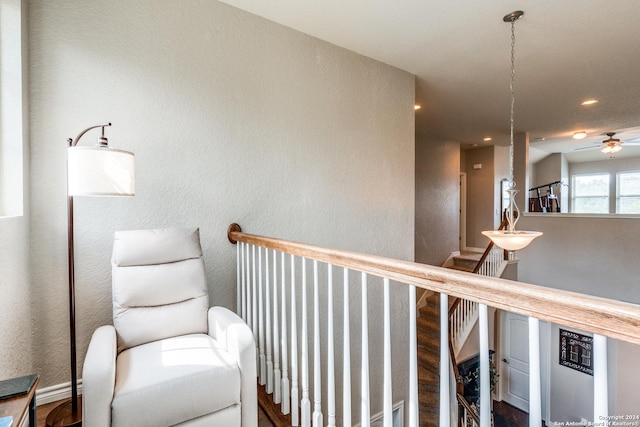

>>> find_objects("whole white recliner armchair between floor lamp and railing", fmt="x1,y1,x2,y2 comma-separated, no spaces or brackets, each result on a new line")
82,228,258,427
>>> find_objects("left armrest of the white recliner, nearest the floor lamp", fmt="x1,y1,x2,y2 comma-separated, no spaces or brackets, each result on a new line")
82,325,117,427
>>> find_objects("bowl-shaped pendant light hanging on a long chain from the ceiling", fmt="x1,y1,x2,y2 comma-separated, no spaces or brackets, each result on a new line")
482,10,542,251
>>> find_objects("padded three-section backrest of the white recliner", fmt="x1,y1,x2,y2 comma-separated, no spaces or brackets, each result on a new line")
111,228,209,352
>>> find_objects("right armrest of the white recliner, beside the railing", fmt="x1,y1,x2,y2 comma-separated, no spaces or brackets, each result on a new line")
208,307,258,427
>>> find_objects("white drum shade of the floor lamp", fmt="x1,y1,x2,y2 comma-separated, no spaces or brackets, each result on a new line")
67,146,135,196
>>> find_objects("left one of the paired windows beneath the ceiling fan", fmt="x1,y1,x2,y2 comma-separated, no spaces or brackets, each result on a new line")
571,174,609,213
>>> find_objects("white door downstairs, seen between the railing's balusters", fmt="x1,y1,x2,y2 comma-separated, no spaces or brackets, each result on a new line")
499,311,549,420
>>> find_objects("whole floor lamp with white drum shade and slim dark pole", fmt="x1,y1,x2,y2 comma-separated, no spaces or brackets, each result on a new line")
46,123,135,427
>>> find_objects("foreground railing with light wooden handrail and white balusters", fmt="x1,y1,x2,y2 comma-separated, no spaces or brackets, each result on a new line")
229,226,640,427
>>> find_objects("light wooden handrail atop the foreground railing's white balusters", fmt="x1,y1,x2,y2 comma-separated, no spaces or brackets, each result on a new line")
227,224,640,345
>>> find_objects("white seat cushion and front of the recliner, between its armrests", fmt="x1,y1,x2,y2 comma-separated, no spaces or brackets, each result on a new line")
111,334,241,427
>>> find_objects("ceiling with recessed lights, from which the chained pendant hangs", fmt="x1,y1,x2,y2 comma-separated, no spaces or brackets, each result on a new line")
223,0,640,162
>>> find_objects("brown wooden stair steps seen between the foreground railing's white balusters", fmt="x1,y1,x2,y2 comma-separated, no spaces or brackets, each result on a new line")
416,294,440,427
